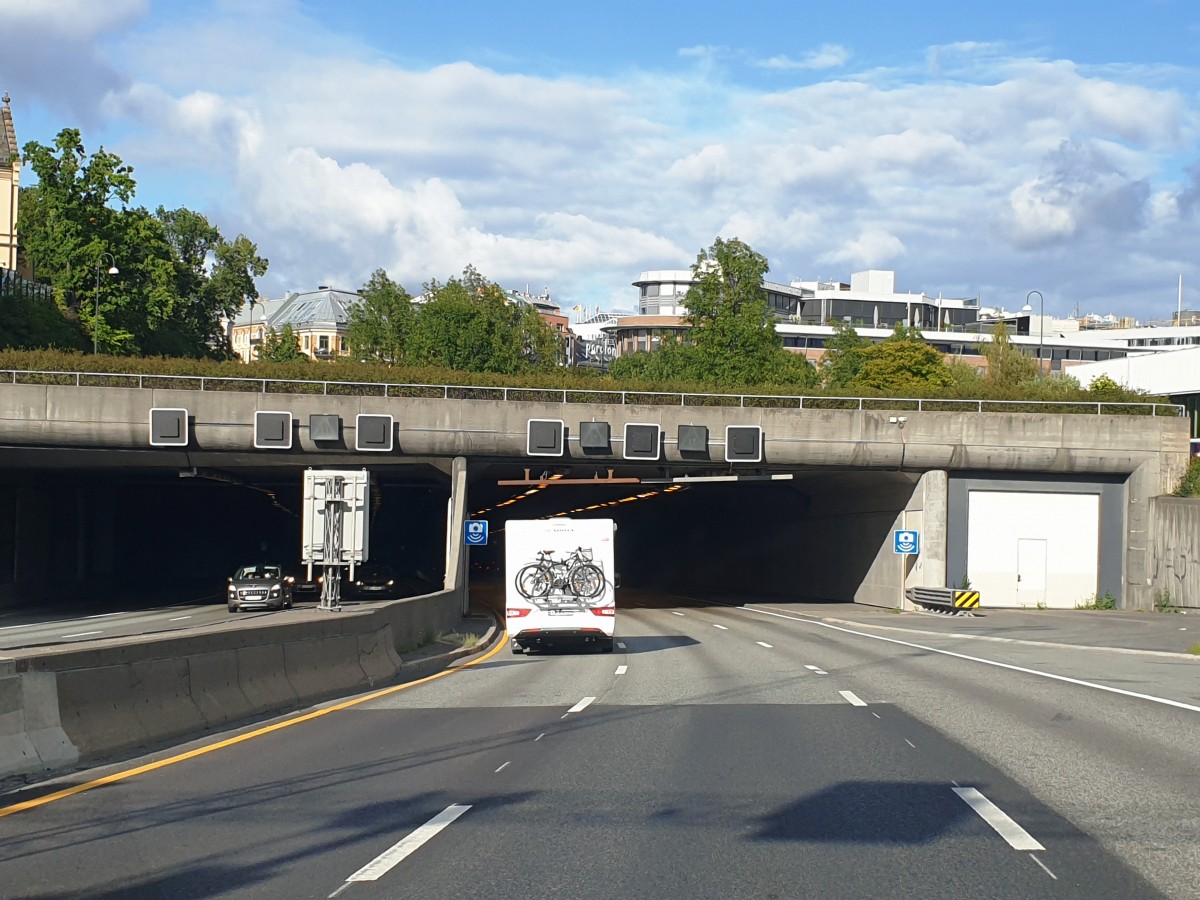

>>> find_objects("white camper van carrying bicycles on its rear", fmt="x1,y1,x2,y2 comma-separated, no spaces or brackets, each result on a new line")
504,517,617,653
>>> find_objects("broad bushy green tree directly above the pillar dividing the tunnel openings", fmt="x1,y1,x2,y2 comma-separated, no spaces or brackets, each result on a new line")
409,265,563,374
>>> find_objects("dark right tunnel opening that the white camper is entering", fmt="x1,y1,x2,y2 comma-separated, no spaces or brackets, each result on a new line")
470,466,920,605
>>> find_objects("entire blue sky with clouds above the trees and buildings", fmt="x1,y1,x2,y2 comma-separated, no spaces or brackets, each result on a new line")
0,0,1200,319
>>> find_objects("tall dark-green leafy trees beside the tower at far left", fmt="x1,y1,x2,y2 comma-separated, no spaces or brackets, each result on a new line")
18,128,268,356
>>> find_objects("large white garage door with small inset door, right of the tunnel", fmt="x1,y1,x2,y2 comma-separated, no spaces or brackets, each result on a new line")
967,491,1100,610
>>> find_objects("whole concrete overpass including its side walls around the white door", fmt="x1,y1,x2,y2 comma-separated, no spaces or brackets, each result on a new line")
0,373,1189,607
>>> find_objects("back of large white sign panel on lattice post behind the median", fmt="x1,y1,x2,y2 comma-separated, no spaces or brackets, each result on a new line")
300,469,371,565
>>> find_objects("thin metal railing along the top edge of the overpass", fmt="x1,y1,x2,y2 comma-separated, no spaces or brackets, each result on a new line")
0,368,1186,416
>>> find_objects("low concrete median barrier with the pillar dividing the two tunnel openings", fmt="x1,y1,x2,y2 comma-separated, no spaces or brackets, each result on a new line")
0,458,467,776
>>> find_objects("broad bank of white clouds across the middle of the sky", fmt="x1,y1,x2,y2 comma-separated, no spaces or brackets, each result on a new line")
16,4,1200,314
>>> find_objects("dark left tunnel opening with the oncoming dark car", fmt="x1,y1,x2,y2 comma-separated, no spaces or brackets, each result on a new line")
0,464,450,613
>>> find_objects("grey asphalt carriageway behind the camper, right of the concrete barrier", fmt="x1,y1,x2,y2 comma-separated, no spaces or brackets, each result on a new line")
0,595,1200,900
